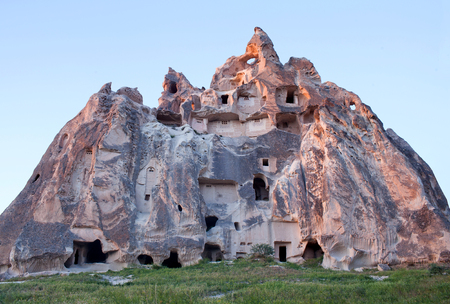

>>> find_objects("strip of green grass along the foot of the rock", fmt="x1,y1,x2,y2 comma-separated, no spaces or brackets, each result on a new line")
0,258,450,303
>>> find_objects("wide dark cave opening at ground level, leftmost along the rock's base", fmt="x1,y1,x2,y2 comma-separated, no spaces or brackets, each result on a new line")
64,240,108,268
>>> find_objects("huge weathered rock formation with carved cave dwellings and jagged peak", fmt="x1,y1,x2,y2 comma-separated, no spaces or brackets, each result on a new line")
0,28,450,274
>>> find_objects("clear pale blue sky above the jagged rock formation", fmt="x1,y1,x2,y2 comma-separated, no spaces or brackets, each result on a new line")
0,0,450,212
